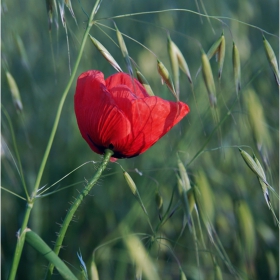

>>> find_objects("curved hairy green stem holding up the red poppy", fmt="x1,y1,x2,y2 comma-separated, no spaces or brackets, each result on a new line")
47,150,113,279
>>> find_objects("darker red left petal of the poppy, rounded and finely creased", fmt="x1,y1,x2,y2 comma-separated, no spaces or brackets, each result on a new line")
75,69,131,153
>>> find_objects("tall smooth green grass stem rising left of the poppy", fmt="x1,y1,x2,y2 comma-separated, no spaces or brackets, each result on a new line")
9,0,102,280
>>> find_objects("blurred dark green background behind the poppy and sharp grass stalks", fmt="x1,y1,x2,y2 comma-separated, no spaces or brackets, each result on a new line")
1,0,279,279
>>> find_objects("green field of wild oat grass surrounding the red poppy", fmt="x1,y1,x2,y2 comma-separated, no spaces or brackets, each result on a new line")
1,0,279,280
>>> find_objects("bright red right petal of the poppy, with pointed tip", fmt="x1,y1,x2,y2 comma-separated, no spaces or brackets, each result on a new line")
107,87,189,157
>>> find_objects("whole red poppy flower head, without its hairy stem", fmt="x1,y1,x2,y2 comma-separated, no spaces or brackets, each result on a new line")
74,70,189,160
